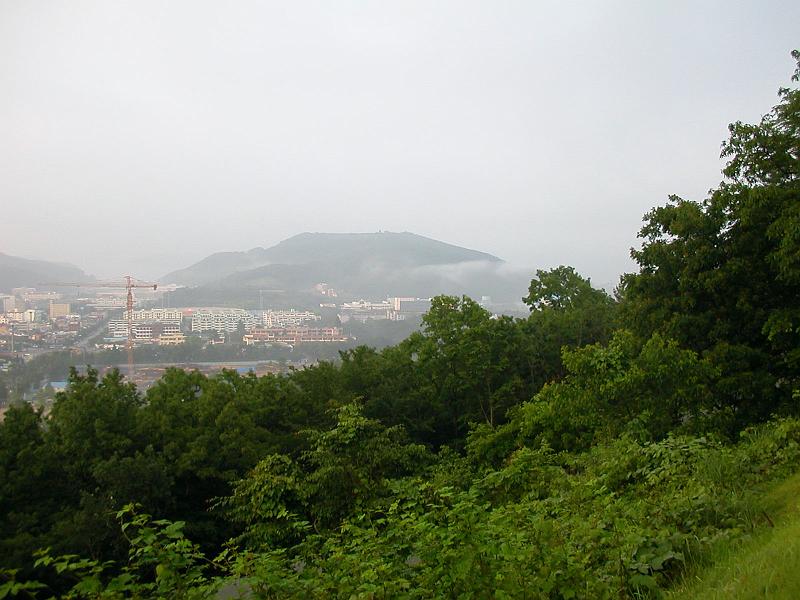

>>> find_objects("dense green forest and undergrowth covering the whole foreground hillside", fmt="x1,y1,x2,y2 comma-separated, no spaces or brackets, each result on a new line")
0,52,800,599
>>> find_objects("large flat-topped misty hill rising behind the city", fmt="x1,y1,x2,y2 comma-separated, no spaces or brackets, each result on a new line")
162,232,525,297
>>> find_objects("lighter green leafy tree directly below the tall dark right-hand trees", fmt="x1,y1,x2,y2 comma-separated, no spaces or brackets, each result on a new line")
476,331,725,454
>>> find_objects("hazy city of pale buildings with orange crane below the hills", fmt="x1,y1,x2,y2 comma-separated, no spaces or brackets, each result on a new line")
0,283,430,395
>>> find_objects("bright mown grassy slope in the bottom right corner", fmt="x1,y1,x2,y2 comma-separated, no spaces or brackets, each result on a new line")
668,473,800,600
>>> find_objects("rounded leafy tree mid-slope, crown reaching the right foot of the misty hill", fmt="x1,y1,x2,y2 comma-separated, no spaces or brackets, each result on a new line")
340,296,531,447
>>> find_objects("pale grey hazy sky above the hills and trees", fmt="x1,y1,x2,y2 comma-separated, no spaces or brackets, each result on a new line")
0,0,800,283
